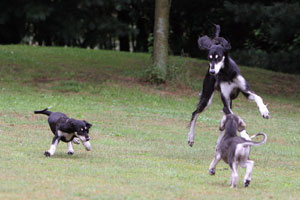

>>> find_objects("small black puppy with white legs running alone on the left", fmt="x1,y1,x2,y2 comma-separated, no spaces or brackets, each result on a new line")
34,108,92,157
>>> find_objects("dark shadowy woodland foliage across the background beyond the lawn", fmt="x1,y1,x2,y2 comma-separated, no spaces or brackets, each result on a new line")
0,0,300,73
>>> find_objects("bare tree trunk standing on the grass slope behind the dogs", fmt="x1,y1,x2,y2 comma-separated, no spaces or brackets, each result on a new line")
153,0,170,81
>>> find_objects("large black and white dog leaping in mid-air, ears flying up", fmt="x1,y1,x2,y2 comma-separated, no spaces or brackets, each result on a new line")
188,25,269,146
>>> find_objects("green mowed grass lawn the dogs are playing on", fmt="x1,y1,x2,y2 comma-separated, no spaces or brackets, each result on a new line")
0,45,300,199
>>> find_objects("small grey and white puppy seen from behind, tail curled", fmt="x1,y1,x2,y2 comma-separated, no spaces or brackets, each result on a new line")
209,114,267,188
